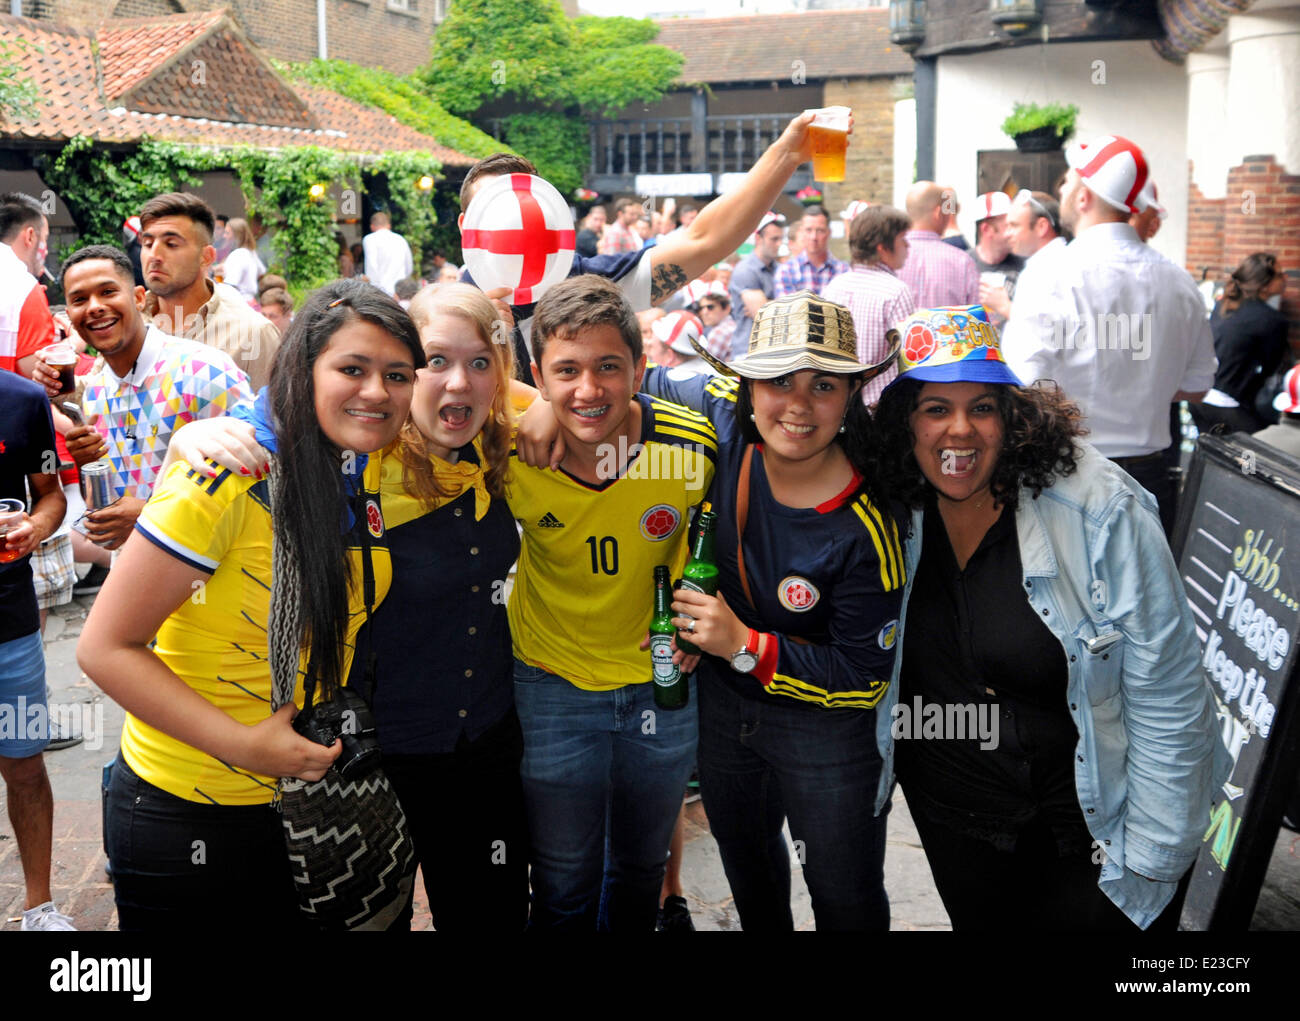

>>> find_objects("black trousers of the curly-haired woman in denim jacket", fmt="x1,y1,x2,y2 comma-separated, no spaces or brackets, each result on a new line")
913,812,1187,933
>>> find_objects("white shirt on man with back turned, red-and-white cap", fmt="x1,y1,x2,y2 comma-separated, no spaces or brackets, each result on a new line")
1002,222,1218,458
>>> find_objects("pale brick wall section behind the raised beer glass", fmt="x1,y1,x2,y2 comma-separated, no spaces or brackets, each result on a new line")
818,78,910,260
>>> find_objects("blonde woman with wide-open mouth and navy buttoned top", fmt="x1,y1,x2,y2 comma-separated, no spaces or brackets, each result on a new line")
161,284,536,933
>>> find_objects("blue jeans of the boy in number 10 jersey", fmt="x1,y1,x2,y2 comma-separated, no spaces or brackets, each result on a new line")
515,659,699,933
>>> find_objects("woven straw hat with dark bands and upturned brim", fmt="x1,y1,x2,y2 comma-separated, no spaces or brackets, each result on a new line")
692,290,900,380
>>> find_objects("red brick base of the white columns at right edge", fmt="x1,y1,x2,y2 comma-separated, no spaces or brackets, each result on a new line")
1187,155,1300,359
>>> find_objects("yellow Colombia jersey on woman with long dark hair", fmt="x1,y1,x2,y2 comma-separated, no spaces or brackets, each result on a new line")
122,454,391,805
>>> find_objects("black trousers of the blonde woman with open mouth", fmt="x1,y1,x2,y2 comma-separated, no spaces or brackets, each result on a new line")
384,708,528,933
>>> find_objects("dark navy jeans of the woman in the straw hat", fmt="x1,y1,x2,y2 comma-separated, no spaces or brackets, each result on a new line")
699,663,889,933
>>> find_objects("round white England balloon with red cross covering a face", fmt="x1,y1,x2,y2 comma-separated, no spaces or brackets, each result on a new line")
460,174,577,304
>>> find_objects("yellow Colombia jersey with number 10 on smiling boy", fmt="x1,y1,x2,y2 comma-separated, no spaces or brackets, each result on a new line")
507,394,718,691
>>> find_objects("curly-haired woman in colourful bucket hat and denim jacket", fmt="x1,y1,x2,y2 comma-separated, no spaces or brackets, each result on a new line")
875,306,1229,931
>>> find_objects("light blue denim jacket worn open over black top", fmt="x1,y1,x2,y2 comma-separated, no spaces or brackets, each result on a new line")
876,444,1231,929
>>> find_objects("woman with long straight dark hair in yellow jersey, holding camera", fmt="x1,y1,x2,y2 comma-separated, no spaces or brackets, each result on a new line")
77,281,425,933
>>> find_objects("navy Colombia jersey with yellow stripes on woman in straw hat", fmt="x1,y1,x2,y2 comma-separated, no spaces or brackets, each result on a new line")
642,368,906,709
